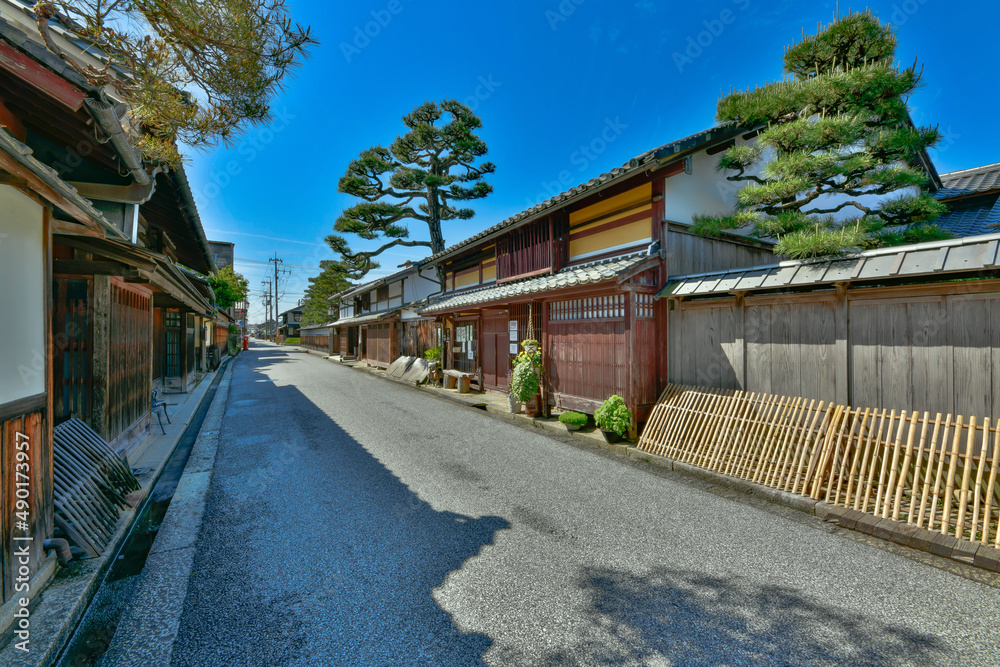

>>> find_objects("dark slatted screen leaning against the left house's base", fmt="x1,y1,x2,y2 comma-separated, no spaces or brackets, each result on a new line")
52,418,139,557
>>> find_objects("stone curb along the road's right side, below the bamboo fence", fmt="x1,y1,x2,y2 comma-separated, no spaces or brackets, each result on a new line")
336,360,1000,572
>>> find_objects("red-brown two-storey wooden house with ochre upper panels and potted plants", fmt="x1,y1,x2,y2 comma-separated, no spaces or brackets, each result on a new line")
420,126,773,422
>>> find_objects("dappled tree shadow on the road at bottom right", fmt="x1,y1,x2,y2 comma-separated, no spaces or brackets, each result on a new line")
539,567,953,667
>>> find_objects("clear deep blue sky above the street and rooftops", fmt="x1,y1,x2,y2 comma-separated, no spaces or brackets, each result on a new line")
188,0,1000,321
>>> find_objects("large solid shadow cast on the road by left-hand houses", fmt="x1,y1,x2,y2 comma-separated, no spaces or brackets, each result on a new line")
171,349,509,667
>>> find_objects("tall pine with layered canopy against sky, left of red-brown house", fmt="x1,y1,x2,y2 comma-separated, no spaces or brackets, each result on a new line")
326,100,496,279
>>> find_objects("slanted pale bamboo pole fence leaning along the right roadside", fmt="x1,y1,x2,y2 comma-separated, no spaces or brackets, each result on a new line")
639,385,1000,548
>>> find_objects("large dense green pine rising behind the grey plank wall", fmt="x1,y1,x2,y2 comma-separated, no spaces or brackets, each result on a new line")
694,11,947,258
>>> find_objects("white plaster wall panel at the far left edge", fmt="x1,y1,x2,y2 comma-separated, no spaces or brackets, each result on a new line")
0,185,46,405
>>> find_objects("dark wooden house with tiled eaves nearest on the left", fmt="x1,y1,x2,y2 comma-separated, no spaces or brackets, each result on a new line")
0,1,219,617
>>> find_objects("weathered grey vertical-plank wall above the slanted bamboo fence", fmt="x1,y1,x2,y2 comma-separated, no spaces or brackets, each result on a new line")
668,280,1000,416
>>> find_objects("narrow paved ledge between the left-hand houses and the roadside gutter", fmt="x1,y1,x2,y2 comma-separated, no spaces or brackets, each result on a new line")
0,357,235,667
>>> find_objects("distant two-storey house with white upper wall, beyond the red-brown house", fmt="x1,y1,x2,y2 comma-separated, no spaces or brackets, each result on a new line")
337,263,441,368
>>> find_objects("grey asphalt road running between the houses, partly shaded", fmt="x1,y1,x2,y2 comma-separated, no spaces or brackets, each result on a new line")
160,345,1000,667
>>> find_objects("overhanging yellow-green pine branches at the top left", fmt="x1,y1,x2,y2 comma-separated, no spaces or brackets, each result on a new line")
35,0,315,164
